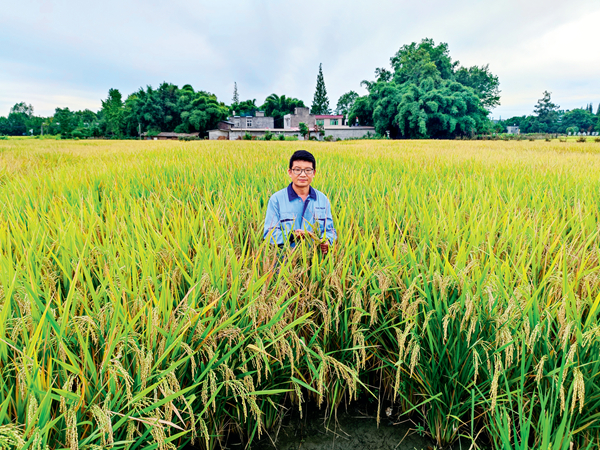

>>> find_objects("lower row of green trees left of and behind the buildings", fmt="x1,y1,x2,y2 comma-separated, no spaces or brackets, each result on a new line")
0,83,304,138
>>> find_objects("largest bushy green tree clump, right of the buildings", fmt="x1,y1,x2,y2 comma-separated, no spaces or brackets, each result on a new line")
349,39,499,138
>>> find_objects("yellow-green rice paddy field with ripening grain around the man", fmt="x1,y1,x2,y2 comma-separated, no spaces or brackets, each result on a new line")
0,140,600,450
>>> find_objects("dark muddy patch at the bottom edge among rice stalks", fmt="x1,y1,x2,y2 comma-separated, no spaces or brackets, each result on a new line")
248,403,435,450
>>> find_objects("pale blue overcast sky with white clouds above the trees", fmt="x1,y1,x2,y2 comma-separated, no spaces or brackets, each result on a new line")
0,0,600,118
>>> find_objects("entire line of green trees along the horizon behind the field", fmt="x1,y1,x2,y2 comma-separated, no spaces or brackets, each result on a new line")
0,39,600,139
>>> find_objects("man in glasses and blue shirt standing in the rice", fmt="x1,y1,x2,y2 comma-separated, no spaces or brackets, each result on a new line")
263,150,337,254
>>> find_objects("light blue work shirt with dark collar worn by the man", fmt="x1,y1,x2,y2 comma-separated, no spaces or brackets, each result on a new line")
263,183,337,247
